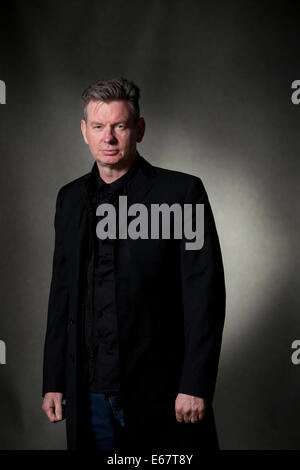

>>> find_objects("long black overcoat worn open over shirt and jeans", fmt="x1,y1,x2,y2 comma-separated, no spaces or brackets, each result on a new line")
42,154,225,453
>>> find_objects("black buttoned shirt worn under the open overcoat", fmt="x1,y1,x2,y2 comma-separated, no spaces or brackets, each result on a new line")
89,154,139,393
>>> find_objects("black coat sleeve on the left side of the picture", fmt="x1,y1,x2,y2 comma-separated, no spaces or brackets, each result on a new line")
42,190,68,396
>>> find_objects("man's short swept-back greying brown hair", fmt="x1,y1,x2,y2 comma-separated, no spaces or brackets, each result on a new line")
81,78,140,122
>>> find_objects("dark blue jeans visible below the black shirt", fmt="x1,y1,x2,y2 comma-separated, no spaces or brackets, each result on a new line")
89,393,125,450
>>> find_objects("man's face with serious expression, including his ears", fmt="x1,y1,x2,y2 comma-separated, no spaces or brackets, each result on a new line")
81,100,145,167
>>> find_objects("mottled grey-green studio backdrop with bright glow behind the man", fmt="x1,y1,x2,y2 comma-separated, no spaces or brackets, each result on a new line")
0,0,300,449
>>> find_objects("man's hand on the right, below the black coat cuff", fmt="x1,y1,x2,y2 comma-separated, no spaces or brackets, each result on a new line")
175,393,206,423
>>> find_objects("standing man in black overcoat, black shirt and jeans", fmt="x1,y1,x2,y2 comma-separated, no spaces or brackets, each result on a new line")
42,78,225,452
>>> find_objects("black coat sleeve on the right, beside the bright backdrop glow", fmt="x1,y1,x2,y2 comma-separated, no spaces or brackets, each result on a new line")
178,178,226,401
